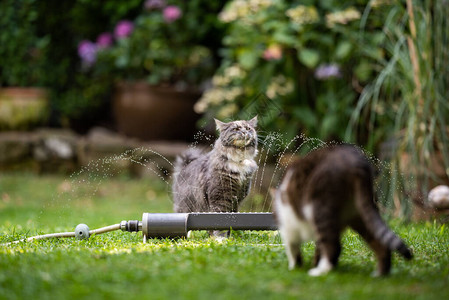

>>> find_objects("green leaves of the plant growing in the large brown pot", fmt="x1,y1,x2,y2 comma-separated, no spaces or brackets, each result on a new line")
93,0,222,86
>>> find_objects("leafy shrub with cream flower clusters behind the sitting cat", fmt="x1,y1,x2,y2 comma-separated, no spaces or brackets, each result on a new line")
196,0,385,140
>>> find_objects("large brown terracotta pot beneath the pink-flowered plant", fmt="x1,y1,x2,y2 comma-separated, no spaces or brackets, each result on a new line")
113,82,200,140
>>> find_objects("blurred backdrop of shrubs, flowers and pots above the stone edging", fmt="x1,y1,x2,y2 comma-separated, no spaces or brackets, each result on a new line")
0,0,449,213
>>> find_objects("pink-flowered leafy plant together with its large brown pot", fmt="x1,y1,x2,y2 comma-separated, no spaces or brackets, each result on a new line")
79,0,226,139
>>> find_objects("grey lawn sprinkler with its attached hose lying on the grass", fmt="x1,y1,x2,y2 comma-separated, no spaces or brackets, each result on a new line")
4,213,277,245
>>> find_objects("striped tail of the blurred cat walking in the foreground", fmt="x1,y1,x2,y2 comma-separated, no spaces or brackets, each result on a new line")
355,164,413,259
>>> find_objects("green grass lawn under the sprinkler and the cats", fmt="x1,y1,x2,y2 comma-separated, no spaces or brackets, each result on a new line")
0,174,449,300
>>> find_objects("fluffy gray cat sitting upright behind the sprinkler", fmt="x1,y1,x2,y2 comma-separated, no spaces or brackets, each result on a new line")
173,117,257,213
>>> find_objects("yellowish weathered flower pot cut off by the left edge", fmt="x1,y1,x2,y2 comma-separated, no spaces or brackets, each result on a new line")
0,87,48,130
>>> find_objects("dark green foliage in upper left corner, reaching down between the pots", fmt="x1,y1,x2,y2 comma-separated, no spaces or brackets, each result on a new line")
5,0,142,125
